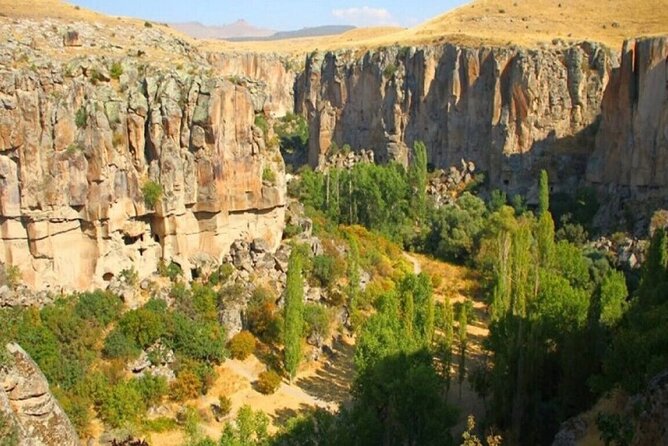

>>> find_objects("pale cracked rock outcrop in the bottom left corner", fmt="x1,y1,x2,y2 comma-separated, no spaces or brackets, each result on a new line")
0,344,79,446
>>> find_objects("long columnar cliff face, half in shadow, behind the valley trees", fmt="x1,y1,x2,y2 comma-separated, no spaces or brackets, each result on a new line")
296,43,614,191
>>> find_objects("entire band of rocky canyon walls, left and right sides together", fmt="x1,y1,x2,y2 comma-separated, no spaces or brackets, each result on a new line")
0,3,668,289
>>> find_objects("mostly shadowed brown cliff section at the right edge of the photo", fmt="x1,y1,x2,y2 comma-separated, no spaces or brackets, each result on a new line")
587,37,668,186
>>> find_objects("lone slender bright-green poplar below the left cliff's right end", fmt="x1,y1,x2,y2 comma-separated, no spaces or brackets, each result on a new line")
283,247,304,382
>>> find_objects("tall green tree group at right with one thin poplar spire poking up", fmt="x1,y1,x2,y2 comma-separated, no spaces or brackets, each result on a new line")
478,172,628,444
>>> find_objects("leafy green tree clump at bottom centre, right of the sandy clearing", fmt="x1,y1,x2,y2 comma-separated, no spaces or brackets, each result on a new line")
275,274,456,445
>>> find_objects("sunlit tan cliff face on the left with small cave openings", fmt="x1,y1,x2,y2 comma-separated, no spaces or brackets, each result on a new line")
0,58,285,288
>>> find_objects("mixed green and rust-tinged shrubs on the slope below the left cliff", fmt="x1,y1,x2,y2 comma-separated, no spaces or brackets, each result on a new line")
0,284,232,435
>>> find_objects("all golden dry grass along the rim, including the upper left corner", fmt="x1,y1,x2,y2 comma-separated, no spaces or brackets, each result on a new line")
0,0,668,55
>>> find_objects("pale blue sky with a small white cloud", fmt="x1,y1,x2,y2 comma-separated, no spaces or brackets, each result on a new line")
70,0,466,31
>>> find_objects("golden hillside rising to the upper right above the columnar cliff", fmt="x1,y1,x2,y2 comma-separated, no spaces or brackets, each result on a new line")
201,0,668,53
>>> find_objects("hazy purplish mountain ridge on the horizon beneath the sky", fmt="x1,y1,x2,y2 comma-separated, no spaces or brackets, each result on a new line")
170,19,355,42
